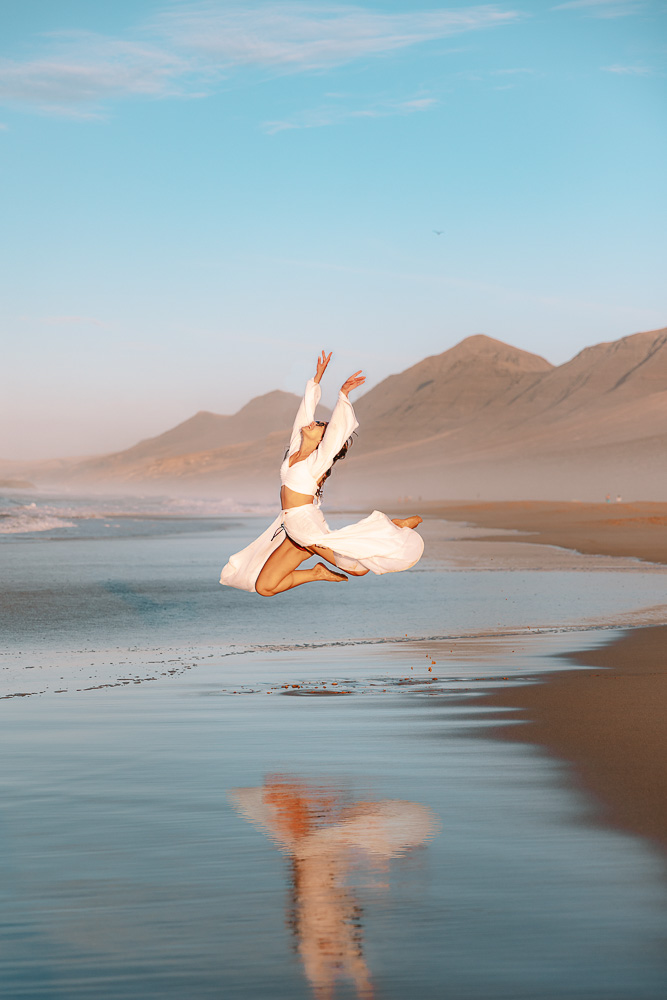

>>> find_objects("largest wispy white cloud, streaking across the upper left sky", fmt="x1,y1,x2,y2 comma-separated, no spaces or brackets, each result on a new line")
0,0,520,118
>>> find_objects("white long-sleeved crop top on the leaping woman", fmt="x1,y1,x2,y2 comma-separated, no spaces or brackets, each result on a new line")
280,378,359,496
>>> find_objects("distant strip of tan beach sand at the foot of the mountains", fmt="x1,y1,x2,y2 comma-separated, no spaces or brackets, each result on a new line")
420,500,667,563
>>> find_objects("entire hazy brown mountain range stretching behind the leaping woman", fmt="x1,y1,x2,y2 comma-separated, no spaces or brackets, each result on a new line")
6,329,667,504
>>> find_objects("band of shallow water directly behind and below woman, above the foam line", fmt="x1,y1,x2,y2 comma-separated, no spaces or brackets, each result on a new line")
0,500,667,652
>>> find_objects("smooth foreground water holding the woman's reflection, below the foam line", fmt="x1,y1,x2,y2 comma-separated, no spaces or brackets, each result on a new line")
0,656,667,1000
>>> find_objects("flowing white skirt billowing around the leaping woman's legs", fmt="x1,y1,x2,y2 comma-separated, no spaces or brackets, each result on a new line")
220,504,424,591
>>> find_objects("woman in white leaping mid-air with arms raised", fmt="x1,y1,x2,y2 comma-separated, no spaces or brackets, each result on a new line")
220,351,424,597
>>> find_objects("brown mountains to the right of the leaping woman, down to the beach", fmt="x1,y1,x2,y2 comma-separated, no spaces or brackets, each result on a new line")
336,329,667,499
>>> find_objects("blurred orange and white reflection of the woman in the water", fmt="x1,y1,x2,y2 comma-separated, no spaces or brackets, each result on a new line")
230,774,437,1000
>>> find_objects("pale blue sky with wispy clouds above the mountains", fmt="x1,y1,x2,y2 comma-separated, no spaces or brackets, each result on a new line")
0,0,667,459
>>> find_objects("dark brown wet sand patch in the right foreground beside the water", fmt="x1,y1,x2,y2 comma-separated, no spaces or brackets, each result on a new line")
482,625,667,851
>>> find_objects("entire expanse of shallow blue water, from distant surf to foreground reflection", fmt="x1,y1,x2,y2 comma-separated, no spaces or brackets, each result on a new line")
0,504,667,1000
